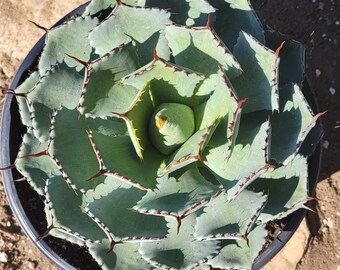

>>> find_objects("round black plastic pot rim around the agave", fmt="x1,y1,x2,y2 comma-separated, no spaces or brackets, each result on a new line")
0,4,321,270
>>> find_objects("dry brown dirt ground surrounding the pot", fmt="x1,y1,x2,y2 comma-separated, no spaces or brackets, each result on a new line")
0,0,340,270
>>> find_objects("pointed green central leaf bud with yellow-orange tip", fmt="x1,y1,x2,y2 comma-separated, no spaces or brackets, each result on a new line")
149,103,195,155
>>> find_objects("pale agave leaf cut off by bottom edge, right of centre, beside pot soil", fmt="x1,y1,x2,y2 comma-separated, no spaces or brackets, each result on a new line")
208,225,268,270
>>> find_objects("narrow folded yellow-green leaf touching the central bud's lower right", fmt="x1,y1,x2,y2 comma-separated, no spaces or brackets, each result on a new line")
158,119,220,176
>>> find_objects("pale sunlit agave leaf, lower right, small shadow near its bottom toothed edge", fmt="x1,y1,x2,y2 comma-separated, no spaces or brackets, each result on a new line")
195,190,268,240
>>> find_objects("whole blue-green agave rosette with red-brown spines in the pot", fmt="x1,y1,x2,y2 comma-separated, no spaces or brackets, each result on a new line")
6,0,321,269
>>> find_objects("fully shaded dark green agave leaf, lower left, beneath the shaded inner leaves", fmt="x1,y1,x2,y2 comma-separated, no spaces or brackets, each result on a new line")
86,182,167,242
